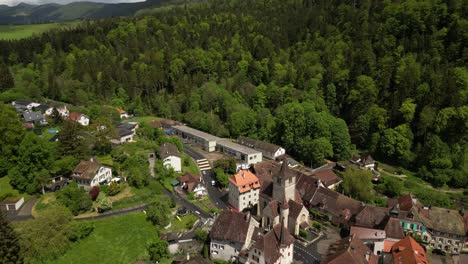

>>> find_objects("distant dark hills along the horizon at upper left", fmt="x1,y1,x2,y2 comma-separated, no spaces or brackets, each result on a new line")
0,0,171,24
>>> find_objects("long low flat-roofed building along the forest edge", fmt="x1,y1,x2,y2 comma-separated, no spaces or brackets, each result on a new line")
172,125,263,164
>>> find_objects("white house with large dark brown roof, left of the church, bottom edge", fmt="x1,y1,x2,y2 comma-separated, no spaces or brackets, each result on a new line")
210,210,258,261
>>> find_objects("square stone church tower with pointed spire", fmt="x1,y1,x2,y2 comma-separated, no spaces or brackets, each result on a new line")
272,160,296,202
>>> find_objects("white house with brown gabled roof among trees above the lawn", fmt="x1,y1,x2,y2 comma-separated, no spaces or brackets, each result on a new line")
71,159,112,190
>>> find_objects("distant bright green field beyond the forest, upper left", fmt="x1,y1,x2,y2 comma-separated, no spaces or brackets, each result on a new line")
0,22,78,40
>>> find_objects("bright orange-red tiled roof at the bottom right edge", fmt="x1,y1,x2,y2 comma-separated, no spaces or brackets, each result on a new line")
392,236,429,264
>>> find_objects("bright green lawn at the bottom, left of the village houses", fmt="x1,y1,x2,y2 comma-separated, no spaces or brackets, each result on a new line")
49,213,156,264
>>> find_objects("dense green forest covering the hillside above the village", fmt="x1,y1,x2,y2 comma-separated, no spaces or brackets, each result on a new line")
0,0,468,190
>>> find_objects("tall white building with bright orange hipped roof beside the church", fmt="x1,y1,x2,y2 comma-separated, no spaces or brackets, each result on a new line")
229,170,260,212
